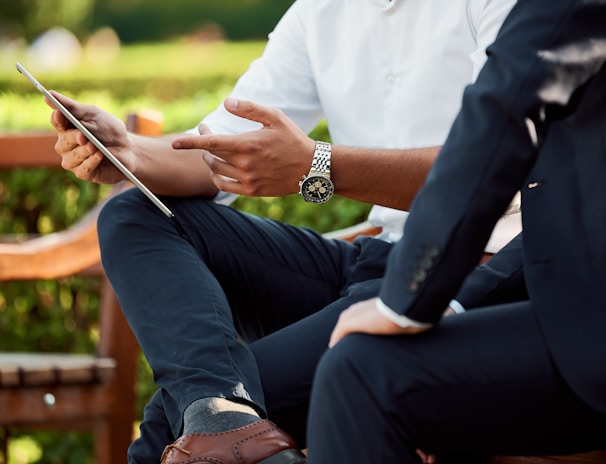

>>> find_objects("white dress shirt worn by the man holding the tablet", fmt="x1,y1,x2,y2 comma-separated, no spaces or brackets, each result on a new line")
197,0,521,251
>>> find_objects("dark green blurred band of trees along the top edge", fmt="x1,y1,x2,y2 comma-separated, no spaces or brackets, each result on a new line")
0,0,292,43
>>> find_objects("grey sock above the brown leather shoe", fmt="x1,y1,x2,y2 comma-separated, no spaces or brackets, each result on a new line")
183,398,261,434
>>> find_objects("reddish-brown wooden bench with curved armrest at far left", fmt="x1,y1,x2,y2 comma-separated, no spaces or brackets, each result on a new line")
0,113,162,464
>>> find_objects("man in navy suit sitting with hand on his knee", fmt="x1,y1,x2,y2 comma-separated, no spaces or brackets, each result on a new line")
308,0,606,464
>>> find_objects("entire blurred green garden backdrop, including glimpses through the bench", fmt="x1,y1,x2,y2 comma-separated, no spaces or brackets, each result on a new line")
0,0,369,464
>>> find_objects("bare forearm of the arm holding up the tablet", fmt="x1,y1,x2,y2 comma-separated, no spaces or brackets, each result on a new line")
130,134,217,197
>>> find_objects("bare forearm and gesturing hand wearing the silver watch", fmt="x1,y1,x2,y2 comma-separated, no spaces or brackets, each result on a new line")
173,98,439,205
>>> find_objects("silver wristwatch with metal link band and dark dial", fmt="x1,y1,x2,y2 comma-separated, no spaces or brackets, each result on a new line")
299,142,335,204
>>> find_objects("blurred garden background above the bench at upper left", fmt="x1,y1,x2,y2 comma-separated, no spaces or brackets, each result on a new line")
0,0,292,131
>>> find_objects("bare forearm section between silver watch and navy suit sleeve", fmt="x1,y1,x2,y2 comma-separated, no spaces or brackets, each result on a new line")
331,145,440,210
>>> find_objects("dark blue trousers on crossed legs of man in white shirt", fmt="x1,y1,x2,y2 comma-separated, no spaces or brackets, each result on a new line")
99,189,391,463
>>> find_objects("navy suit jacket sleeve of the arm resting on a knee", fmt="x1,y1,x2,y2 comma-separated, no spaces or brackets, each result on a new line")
379,0,606,323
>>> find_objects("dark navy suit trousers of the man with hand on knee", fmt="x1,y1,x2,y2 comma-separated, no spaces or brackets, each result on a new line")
308,302,606,464
